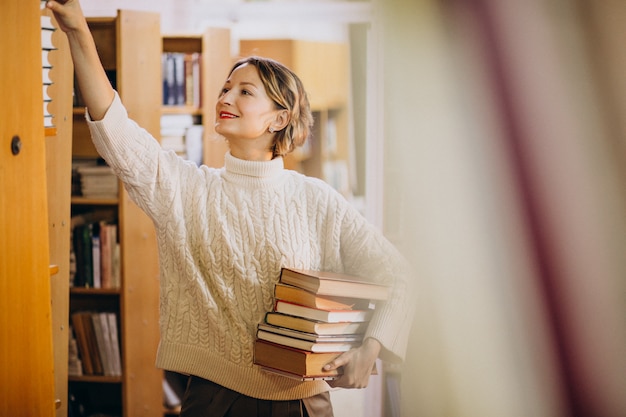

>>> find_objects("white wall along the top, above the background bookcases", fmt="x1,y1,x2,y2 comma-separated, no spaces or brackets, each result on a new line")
81,0,364,53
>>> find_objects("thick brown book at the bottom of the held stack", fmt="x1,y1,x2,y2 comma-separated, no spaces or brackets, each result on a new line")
254,340,341,378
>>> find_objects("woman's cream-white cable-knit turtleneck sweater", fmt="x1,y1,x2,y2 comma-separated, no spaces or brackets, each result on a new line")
87,94,414,400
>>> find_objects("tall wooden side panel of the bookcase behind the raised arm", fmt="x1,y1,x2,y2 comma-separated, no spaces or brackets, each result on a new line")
116,10,163,416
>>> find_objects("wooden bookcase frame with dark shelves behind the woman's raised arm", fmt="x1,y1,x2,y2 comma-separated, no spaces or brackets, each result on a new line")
69,10,163,416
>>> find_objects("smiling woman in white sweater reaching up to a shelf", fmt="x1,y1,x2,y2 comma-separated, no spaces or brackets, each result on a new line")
47,0,414,417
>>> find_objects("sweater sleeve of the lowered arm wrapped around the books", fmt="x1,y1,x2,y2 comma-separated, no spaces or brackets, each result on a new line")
341,203,416,363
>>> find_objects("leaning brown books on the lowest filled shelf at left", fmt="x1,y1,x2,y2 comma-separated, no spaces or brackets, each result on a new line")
69,311,122,376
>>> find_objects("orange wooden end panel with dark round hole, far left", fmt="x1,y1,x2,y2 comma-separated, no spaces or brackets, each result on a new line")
0,2,54,416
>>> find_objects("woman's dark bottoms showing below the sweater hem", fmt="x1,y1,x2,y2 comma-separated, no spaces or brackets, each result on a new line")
180,376,333,417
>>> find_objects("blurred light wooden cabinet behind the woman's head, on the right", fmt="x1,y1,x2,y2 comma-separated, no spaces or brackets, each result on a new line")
239,39,352,195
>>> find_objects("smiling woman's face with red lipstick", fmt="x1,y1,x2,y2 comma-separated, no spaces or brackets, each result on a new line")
215,64,279,146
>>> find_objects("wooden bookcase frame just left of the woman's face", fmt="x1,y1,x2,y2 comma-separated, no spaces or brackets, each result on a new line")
163,28,232,168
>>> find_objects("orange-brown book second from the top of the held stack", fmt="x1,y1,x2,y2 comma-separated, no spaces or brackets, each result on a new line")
274,282,369,310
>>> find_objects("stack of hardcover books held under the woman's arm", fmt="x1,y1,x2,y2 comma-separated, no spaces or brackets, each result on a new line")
254,268,389,380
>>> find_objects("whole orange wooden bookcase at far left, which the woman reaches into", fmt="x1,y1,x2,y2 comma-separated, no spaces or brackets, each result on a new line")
0,2,71,417
